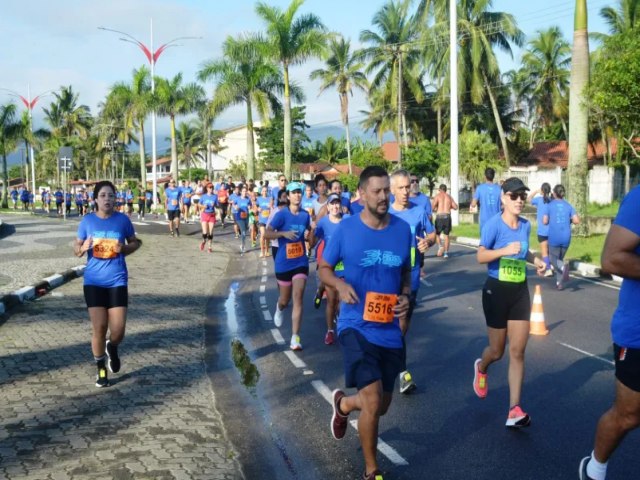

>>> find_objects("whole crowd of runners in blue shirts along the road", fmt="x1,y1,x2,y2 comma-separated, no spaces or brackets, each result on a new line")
67,167,640,480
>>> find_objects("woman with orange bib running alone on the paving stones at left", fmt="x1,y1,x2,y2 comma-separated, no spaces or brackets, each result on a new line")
73,181,141,387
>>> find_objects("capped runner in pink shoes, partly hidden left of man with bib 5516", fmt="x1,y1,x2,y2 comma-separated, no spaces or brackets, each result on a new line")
309,193,349,345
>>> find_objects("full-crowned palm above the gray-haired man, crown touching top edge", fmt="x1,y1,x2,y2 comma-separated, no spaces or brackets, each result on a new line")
360,0,424,160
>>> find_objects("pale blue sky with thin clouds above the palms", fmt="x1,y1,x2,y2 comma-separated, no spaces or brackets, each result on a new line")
0,0,617,142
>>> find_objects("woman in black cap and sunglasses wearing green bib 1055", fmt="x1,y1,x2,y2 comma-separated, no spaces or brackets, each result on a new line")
473,177,547,428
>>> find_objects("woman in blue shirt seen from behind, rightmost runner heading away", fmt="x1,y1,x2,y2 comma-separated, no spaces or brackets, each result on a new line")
542,185,580,290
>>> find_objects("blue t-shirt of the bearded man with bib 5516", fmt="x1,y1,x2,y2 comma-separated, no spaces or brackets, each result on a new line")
323,215,411,348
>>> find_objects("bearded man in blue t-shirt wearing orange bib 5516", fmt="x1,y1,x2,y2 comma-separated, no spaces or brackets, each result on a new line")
319,166,411,480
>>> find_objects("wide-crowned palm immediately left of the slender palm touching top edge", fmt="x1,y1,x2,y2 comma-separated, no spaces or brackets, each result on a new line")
198,36,285,178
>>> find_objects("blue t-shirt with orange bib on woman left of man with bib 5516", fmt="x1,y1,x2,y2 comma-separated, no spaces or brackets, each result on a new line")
269,208,311,273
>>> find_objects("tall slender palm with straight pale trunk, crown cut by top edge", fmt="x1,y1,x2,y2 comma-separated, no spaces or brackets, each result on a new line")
256,0,326,178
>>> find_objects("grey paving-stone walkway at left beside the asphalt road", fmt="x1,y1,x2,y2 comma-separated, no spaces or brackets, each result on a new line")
0,227,243,480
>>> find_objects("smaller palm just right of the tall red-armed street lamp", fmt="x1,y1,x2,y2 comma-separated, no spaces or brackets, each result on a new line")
155,73,205,181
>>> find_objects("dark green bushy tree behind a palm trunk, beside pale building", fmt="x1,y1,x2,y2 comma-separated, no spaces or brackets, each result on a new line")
256,107,310,171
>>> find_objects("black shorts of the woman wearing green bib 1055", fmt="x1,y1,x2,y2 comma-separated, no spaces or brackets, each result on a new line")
482,277,531,328
